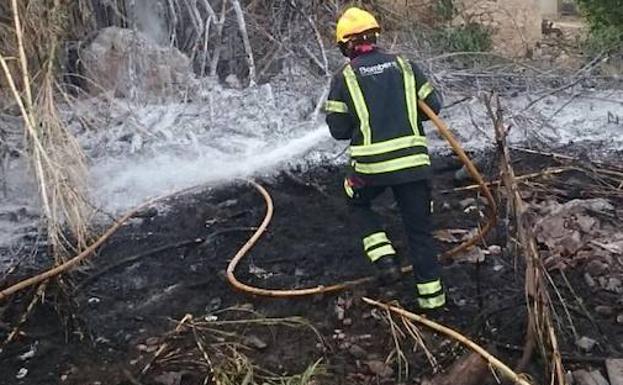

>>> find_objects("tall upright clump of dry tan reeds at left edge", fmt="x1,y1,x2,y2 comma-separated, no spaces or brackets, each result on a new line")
0,0,90,263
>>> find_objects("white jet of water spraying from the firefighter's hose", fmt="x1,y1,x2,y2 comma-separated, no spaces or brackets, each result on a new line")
91,125,330,211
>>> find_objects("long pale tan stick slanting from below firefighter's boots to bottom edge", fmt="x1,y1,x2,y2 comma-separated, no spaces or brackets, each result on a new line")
363,297,531,385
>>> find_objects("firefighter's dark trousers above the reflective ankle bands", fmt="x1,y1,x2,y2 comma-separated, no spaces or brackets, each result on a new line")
345,180,441,283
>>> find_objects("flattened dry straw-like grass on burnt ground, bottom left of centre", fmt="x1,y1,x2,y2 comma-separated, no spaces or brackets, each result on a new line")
142,308,325,385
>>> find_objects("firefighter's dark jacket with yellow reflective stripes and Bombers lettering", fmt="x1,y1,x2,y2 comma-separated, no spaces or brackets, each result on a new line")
325,49,441,186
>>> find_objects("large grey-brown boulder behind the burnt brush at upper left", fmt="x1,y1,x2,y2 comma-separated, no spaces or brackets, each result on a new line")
80,27,194,97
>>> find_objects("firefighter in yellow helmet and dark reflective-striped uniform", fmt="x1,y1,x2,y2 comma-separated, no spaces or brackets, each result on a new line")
325,7,446,310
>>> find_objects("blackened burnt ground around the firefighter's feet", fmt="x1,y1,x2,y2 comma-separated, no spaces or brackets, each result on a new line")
0,151,623,385
